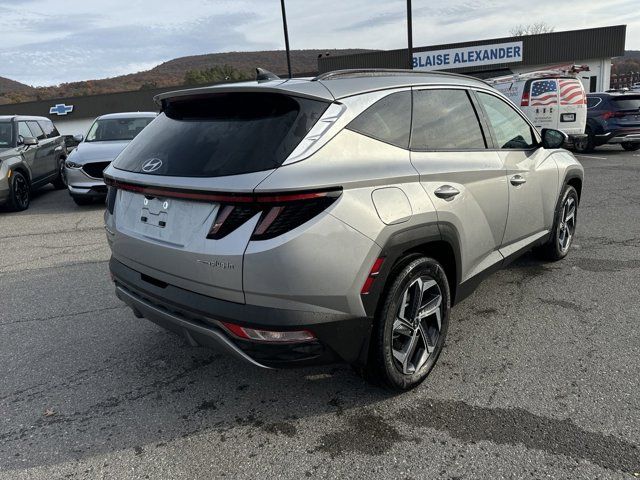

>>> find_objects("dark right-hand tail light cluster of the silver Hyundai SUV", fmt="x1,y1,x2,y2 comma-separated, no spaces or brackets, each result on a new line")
207,189,342,240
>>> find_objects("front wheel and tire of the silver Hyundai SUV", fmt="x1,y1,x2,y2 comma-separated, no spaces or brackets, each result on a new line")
534,185,579,262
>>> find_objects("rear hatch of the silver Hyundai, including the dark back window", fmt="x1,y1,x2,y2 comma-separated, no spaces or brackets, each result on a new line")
105,92,328,303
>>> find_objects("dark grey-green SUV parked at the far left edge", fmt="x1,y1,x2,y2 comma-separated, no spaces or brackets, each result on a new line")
0,115,67,211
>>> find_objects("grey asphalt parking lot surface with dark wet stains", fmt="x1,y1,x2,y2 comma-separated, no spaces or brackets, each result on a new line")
0,147,640,480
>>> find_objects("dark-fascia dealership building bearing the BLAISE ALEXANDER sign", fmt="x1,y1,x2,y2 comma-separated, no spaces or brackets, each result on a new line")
318,25,626,92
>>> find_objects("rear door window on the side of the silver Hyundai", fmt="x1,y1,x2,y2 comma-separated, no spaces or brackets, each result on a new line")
411,90,487,150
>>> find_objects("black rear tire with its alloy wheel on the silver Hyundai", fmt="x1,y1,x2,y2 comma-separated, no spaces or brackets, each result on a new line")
363,257,451,391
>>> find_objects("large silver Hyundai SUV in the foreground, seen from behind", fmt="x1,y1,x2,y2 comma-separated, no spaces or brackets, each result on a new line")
105,70,583,390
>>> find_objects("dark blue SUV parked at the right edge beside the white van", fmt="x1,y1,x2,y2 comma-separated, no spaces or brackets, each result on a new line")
578,93,640,153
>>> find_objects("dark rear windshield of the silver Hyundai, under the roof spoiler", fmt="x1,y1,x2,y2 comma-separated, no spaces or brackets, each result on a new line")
114,92,329,177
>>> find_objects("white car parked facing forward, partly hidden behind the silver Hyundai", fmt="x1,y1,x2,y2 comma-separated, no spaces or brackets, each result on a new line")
65,112,157,205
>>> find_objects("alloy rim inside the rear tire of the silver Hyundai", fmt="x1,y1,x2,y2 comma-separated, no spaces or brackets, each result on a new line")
391,276,443,375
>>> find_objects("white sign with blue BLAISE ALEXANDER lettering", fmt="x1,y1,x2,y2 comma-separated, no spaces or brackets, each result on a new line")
413,42,522,70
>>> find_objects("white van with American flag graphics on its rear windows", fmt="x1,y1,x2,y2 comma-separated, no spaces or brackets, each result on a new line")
487,69,587,139
